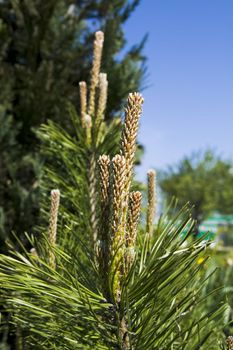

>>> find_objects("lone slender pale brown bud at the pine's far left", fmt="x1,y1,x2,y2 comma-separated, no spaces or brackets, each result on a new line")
48,190,60,268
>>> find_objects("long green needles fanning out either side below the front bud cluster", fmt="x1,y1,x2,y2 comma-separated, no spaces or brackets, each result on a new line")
0,208,227,350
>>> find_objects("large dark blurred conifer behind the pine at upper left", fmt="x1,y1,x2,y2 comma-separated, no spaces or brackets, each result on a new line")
0,0,145,247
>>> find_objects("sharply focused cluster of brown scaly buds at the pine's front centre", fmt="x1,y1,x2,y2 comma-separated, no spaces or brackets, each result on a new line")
98,93,146,301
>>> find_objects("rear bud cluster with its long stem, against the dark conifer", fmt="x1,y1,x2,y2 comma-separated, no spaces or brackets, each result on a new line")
79,31,108,251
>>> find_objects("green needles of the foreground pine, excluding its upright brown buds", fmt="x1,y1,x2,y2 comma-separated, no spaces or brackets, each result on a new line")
0,87,229,350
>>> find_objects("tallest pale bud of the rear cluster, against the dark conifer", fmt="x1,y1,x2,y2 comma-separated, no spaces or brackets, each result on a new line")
88,31,104,116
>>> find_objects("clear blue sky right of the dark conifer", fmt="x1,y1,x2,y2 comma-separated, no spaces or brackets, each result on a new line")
125,0,233,180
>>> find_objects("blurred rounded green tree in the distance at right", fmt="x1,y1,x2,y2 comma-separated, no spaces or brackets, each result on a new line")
160,150,233,232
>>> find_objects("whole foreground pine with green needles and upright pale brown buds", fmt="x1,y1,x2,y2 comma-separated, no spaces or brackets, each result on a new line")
0,32,230,350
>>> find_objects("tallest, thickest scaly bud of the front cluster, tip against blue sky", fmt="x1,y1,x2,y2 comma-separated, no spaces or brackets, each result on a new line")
121,92,144,195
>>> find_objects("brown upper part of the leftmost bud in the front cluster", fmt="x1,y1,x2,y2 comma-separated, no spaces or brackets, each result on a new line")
98,155,110,205
